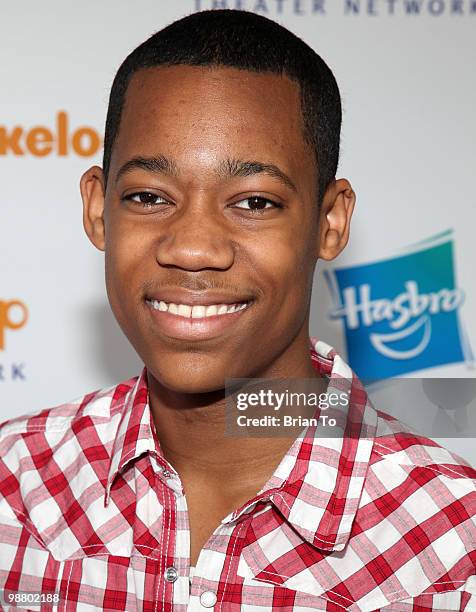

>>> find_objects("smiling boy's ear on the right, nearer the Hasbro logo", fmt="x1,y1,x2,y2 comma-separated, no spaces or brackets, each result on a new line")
318,179,355,260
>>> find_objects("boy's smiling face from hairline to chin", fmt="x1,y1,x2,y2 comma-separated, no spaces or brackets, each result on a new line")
82,66,350,393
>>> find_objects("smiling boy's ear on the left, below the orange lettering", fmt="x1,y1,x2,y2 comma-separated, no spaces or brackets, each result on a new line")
80,166,106,251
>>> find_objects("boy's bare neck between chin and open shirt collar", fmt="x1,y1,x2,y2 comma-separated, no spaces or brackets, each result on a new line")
149,342,325,489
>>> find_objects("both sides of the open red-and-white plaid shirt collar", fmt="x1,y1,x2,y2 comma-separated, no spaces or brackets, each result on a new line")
104,338,377,552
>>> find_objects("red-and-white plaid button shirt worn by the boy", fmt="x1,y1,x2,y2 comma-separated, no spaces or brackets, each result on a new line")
0,338,476,612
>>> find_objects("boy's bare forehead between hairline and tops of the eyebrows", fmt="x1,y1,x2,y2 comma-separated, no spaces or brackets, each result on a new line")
119,65,304,148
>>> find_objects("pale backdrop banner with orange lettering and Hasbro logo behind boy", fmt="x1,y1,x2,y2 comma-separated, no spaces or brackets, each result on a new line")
0,0,476,463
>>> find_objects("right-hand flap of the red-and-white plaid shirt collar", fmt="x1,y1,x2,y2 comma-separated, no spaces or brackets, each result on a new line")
223,338,377,552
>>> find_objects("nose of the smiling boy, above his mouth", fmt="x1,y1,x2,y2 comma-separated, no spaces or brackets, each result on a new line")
156,198,235,270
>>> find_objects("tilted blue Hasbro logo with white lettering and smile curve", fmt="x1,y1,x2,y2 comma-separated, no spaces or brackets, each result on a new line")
324,231,472,379
